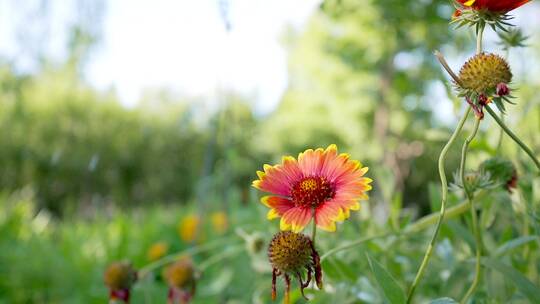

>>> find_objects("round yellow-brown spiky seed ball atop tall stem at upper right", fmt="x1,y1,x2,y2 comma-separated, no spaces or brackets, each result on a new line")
459,53,512,94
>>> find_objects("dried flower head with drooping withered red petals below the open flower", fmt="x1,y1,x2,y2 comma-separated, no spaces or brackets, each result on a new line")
268,231,323,302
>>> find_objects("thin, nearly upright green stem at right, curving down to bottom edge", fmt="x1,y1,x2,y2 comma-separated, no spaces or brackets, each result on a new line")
459,118,482,304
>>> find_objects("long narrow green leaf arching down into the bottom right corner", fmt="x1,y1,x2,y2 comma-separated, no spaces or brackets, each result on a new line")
482,258,540,303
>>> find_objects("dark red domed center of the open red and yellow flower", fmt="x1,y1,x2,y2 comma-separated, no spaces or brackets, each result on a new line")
291,177,336,207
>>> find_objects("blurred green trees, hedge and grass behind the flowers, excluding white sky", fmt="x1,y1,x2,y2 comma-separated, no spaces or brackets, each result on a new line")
0,0,540,303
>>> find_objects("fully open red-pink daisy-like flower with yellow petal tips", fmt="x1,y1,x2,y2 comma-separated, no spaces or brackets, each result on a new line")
253,145,372,232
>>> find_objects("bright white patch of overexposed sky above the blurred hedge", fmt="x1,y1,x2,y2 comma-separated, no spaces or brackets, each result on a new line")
87,0,318,112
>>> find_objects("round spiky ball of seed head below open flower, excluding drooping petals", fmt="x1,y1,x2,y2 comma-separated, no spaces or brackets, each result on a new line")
268,231,313,274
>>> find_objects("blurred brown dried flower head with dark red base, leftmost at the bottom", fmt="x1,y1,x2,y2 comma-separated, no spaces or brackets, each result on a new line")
103,261,137,303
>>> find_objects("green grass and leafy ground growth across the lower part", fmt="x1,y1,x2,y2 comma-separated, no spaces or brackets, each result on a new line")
0,173,540,303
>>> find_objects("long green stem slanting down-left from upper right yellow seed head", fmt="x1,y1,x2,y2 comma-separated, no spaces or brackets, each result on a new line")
407,107,471,303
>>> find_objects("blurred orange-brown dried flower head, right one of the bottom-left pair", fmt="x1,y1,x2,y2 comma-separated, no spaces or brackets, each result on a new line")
162,257,196,303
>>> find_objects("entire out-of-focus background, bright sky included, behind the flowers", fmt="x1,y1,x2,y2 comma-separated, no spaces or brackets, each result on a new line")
0,0,540,303
